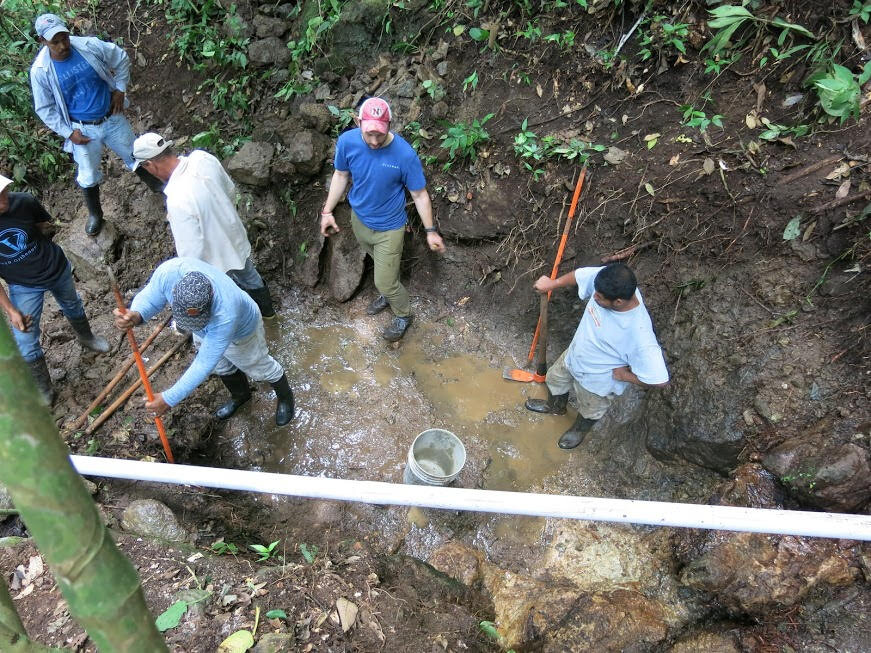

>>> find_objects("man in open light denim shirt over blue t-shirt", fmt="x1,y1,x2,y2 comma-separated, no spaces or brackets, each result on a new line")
30,14,163,236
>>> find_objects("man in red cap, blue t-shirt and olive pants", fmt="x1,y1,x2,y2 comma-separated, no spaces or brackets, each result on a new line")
321,98,445,342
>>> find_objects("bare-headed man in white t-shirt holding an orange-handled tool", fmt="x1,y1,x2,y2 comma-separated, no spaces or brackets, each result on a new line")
526,263,668,449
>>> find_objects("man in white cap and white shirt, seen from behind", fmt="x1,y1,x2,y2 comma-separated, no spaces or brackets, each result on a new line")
126,132,275,320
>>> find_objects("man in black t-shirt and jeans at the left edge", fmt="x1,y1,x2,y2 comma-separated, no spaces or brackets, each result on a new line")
0,175,109,404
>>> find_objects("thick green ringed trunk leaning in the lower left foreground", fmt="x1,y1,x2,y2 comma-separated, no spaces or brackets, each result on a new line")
0,320,167,653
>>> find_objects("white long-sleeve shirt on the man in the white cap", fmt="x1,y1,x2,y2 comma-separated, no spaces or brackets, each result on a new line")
163,150,251,272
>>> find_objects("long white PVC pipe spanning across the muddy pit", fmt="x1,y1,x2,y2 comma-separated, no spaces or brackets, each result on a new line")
70,456,871,540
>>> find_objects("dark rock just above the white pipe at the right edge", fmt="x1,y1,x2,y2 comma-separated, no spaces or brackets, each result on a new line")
763,432,871,512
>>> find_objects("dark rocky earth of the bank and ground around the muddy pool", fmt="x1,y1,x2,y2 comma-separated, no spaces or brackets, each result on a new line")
0,2,871,651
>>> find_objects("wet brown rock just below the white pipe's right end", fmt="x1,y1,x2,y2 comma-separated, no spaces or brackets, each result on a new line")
680,532,858,616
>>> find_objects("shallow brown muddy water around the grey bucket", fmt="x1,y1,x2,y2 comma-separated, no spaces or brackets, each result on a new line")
225,299,724,565
